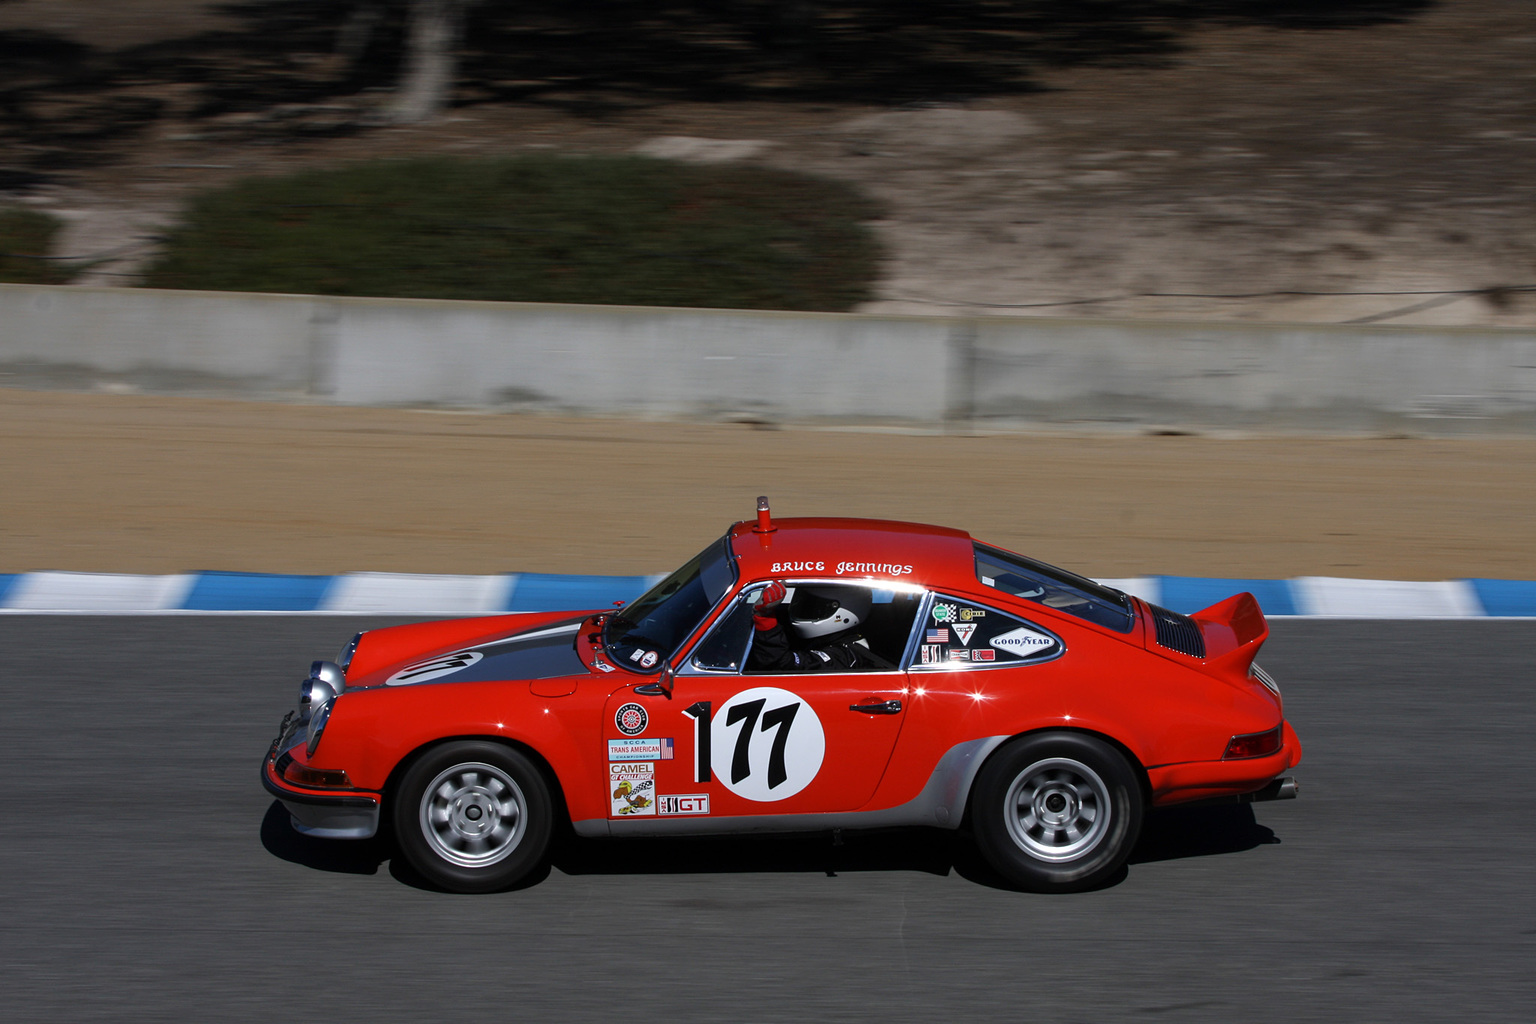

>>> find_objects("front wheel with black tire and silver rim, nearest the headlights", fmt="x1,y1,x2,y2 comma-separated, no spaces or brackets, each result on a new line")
392,740,554,892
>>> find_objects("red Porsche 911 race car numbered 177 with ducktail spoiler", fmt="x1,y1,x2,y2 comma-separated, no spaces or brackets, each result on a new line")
261,500,1301,892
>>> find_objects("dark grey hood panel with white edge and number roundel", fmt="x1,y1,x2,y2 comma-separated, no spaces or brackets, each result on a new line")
358,617,587,686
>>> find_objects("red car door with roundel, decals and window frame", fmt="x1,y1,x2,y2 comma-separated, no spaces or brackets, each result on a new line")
604,583,922,817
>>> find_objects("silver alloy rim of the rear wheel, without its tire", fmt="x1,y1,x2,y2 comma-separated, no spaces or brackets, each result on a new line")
1003,757,1111,861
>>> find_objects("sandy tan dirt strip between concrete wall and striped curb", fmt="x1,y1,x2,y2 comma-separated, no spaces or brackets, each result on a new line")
0,388,1536,579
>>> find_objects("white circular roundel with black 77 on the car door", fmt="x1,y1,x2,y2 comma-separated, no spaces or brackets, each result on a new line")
710,686,826,803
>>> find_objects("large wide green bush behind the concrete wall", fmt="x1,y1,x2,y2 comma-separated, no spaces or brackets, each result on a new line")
146,155,880,310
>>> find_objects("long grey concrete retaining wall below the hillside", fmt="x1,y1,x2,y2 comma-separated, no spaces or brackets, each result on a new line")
0,286,1536,434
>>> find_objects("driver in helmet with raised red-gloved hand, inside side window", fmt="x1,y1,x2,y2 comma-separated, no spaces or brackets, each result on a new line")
746,580,895,672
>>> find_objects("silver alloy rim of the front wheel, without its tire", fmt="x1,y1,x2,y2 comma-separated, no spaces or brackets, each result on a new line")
421,761,528,867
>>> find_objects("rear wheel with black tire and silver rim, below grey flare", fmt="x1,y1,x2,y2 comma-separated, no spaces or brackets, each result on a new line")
971,732,1144,892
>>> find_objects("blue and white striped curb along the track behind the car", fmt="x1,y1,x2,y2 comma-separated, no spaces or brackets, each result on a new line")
0,573,1536,619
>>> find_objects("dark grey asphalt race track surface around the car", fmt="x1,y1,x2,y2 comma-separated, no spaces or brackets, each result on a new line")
0,616,1536,1024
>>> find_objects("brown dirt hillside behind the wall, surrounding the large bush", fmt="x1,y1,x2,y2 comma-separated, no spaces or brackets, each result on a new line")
0,0,1536,325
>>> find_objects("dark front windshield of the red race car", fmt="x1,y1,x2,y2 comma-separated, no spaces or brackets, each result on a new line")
604,537,736,672
